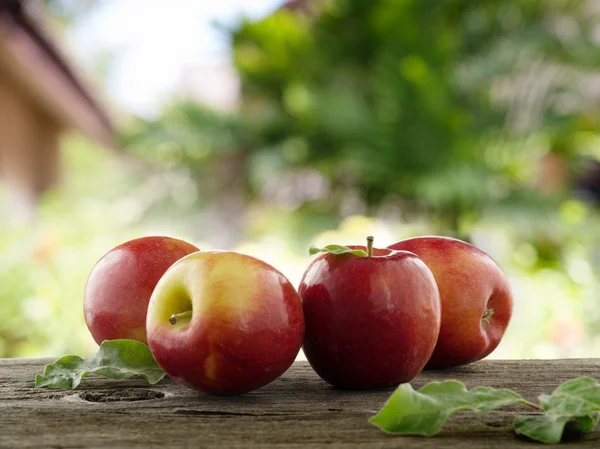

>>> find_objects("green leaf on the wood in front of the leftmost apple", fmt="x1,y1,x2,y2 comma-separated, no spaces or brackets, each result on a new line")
35,340,165,389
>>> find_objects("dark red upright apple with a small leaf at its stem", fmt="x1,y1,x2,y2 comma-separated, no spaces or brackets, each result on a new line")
299,238,440,389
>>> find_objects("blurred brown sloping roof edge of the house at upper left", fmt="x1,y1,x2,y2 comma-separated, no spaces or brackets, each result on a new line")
0,0,116,148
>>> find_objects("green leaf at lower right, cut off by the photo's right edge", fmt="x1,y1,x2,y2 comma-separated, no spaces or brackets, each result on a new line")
513,377,600,444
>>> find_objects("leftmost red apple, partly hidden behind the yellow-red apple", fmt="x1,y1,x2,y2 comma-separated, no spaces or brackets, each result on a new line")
83,236,199,344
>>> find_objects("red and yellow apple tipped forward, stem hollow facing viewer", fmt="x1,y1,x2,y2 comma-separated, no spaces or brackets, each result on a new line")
147,251,304,395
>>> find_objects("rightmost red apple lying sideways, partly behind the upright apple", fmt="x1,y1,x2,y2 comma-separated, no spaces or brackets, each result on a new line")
389,236,513,368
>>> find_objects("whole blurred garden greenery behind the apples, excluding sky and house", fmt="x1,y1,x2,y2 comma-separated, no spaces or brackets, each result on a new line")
0,0,600,357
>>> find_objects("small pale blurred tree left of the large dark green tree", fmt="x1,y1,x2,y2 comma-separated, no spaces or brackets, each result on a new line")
122,100,257,248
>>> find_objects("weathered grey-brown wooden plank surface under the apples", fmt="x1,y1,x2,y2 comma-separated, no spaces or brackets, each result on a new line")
0,359,600,449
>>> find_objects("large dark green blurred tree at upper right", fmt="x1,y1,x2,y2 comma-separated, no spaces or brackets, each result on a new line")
233,0,600,237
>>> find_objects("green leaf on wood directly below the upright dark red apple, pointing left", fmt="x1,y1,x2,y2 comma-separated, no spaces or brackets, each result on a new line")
369,380,527,436
